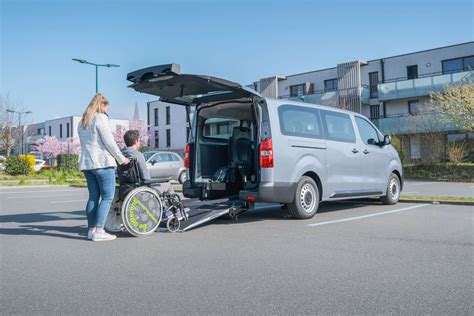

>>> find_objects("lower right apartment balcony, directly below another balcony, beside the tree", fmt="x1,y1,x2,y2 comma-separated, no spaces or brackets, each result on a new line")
373,112,460,135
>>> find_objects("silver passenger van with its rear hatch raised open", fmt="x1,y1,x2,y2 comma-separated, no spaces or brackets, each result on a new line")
127,64,403,219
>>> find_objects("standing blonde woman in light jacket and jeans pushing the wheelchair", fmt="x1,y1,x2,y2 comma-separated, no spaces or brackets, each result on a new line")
78,93,130,241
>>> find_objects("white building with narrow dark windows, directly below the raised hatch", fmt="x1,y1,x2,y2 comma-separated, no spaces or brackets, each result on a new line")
147,101,189,154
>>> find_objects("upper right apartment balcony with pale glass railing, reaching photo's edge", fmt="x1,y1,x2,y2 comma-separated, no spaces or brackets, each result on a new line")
378,71,474,101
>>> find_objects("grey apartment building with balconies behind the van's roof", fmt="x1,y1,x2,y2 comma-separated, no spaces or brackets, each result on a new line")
249,42,474,160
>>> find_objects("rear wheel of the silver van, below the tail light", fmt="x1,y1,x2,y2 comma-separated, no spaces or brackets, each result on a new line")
287,176,319,219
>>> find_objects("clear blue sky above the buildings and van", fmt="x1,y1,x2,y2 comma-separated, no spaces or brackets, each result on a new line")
0,0,474,122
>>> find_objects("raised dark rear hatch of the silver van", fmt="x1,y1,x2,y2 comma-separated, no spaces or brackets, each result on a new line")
127,64,261,106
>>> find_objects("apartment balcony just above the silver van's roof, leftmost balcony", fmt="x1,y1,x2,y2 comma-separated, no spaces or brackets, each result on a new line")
279,86,370,107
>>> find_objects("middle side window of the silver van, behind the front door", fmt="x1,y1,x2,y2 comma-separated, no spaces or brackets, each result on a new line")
320,110,355,143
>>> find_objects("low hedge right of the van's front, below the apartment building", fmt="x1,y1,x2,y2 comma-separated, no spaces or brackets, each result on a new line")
403,163,474,182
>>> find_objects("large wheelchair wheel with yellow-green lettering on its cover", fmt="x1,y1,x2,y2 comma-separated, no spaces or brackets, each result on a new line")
122,187,162,237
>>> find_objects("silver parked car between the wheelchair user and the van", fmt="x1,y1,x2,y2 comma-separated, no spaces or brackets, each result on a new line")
144,151,186,183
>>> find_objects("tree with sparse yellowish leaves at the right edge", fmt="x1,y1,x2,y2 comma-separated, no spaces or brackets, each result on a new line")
430,80,474,133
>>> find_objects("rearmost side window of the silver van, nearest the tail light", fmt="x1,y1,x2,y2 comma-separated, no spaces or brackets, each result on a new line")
278,105,323,138
